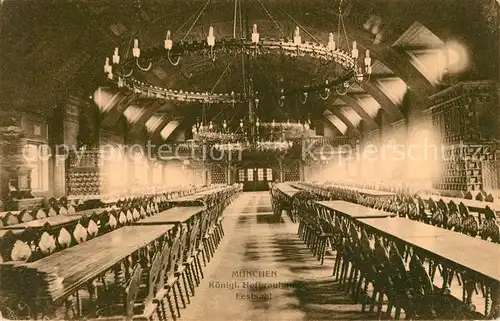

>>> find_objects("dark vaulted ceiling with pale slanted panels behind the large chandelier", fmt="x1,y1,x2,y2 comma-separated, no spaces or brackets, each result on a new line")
0,0,499,139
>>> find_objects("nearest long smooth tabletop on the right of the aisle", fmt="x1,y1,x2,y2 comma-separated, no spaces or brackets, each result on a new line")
358,218,500,282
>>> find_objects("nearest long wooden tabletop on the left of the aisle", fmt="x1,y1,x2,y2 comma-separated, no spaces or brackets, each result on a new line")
12,225,173,303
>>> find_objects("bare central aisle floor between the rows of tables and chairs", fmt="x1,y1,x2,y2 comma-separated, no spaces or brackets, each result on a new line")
182,192,374,321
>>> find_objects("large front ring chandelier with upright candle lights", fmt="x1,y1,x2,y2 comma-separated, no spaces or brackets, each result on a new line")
104,0,372,104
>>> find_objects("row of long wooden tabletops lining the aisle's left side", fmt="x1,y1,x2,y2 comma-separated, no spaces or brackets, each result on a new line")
15,207,205,304
